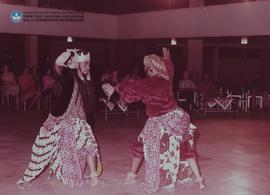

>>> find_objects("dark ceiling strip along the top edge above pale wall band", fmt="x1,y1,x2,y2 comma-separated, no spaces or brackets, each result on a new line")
0,0,256,15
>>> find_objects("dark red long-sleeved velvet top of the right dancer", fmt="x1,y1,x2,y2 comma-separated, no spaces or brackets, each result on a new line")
119,60,178,117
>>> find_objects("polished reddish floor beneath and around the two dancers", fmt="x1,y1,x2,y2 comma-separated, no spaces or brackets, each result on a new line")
0,110,270,195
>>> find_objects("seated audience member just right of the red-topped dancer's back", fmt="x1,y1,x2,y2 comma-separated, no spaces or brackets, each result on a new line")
178,70,196,110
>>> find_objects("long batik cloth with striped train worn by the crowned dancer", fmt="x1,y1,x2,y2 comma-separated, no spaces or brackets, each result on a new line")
17,81,98,187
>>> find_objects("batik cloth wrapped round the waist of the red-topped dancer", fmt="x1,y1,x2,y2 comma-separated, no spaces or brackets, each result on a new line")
143,108,190,193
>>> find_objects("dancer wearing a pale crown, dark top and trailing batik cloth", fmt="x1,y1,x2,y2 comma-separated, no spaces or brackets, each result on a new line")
17,49,100,188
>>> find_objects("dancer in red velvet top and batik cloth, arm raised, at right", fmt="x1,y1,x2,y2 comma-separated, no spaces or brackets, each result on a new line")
116,48,204,193
